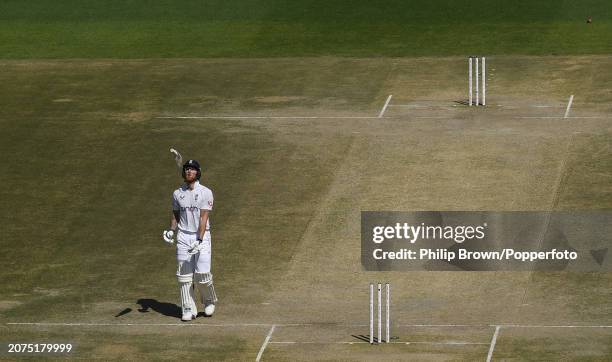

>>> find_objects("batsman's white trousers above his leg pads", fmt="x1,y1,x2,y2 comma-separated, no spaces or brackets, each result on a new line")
176,230,212,275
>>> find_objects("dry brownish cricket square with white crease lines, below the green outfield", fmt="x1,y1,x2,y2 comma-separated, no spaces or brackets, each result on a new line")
0,56,612,360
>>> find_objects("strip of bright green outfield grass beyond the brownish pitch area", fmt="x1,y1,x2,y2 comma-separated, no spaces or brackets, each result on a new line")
0,0,612,59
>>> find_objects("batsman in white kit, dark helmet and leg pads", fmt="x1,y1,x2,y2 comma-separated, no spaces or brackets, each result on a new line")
163,160,217,321
